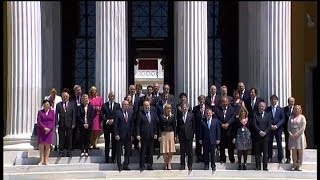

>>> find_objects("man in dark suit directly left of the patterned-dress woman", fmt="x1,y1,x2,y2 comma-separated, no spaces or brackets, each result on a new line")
216,97,235,163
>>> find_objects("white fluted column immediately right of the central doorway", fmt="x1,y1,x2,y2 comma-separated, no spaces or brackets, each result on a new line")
174,1,208,108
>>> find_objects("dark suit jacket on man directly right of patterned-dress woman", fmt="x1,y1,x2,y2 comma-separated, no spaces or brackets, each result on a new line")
253,112,272,140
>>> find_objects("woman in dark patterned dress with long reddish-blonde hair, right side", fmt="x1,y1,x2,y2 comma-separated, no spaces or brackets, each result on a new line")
234,106,252,170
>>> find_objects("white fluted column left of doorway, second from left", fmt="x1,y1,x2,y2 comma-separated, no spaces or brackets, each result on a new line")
96,1,128,103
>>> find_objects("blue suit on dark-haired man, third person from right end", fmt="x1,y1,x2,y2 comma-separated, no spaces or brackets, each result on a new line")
267,106,285,162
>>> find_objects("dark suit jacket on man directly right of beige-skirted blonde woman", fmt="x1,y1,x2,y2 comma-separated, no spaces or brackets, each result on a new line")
177,112,196,141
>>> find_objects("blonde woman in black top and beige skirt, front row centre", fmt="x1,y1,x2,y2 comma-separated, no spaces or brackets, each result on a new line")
159,104,176,170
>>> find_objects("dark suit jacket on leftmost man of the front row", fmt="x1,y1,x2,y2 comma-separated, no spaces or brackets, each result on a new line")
114,109,134,140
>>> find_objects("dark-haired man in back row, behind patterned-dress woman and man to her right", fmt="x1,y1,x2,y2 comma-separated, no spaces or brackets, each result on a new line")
244,88,264,155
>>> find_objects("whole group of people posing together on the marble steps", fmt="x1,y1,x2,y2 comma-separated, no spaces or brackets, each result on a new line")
38,82,306,171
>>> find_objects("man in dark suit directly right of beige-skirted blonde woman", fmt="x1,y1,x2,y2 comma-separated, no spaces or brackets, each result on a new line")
177,103,195,171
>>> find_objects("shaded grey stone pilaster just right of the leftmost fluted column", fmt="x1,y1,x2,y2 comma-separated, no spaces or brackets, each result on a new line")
41,1,62,98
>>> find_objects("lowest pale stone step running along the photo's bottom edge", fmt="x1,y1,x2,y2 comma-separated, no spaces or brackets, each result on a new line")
3,166,317,180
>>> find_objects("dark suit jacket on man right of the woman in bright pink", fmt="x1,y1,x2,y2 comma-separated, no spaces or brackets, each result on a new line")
100,101,120,129
